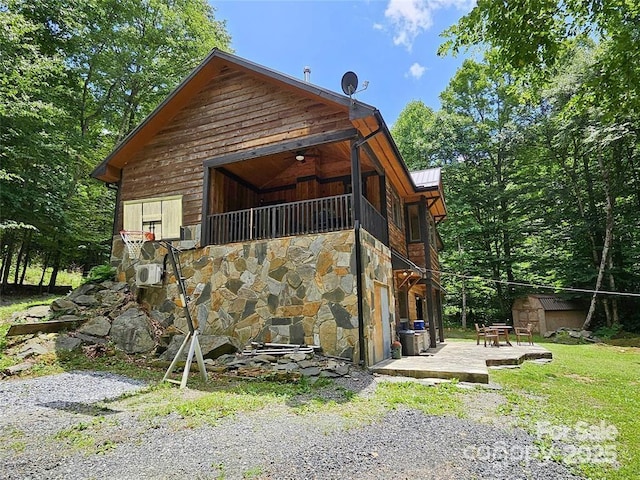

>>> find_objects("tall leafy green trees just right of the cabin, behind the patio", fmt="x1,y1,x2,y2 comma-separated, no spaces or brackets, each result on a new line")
393,54,539,321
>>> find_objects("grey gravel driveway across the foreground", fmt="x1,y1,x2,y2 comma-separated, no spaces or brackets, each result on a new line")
0,372,579,480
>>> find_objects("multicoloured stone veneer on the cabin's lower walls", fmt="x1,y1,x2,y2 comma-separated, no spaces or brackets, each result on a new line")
111,230,370,362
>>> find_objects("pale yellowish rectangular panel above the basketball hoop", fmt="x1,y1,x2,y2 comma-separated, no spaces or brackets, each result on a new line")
122,196,182,240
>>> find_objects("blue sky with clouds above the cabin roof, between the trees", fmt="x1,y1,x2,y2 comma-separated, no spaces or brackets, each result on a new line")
210,0,474,126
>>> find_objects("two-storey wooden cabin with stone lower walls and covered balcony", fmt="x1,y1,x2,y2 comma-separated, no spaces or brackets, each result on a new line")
93,50,446,365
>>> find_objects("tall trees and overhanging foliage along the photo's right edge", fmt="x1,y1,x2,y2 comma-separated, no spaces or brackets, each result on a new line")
441,0,640,328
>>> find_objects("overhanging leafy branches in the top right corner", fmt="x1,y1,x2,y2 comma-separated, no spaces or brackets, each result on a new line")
440,0,640,118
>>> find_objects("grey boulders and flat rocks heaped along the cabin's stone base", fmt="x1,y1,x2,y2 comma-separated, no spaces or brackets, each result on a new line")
4,281,350,378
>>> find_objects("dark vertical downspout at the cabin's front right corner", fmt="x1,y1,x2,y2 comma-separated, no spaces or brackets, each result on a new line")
351,128,381,365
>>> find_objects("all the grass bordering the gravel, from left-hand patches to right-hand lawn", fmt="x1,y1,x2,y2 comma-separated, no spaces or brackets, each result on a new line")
0,297,640,480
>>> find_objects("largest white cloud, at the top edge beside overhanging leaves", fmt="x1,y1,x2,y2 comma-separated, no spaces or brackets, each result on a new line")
382,0,475,51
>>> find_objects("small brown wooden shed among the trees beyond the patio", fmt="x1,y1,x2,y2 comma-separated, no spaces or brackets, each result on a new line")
512,295,587,335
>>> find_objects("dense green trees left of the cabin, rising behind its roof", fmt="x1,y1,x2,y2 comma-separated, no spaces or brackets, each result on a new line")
0,0,230,292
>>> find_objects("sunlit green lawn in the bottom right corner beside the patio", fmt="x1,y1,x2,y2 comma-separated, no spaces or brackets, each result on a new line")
490,343,640,479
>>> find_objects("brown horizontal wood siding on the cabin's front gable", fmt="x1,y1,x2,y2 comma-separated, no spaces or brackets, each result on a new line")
121,68,352,229
